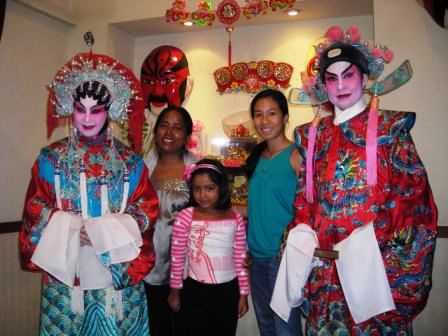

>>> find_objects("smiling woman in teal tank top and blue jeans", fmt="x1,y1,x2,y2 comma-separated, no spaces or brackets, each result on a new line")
246,89,302,336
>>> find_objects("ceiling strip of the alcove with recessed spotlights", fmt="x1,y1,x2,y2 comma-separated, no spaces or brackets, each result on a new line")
113,0,373,37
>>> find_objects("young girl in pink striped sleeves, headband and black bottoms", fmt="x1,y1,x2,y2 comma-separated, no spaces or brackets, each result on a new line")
168,159,249,336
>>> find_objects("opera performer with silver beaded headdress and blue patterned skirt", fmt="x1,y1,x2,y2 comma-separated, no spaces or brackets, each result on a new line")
19,46,158,336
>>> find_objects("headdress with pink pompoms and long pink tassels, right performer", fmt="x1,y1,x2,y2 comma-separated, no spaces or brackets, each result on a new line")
289,26,412,203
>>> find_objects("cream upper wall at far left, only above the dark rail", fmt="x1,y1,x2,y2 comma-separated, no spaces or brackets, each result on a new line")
0,1,71,222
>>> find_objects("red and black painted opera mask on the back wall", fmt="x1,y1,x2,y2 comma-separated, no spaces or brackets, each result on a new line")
140,45,190,110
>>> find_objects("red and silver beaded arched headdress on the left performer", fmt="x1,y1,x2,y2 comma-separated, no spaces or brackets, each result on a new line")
47,41,145,153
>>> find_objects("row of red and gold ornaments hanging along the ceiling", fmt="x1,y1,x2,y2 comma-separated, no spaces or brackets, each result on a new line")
165,0,296,26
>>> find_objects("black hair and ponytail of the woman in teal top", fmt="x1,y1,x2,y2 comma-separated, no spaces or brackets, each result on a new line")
246,89,289,179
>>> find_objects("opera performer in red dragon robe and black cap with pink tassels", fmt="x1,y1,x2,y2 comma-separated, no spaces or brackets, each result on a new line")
271,26,437,335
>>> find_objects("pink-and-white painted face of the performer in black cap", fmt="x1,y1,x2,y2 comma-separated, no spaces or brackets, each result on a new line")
324,61,367,111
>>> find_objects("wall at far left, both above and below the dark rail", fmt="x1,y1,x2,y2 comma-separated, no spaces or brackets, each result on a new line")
0,1,71,336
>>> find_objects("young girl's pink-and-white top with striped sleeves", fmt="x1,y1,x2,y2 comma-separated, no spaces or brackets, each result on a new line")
170,207,249,295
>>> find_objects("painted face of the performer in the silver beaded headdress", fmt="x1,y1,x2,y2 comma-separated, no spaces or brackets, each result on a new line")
73,97,107,137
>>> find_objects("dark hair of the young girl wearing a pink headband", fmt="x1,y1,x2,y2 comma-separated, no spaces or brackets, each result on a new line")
188,158,232,210
